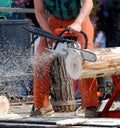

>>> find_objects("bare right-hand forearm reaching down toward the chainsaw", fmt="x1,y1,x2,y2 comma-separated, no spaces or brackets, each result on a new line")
76,0,93,23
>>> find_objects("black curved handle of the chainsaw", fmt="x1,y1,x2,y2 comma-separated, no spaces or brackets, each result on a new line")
59,28,88,49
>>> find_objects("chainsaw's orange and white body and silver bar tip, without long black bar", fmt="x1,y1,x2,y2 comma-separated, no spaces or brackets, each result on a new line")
52,28,96,62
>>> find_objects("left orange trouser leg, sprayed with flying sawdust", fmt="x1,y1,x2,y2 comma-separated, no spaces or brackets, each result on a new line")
34,39,52,108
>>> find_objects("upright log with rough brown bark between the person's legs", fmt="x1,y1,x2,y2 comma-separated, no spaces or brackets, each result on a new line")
50,56,76,112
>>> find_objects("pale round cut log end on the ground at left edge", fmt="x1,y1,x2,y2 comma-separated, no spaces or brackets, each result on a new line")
0,96,10,116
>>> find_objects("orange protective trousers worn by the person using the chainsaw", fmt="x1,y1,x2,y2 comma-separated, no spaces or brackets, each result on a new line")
34,16,98,108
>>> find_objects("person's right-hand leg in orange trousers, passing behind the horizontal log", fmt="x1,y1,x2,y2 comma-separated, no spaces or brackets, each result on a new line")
78,17,98,117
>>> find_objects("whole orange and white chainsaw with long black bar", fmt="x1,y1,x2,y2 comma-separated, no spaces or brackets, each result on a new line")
23,26,97,62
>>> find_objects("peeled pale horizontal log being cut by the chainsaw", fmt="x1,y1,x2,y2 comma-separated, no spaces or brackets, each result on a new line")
66,47,120,79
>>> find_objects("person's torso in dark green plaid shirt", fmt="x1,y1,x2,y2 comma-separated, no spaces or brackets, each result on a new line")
44,0,81,20
